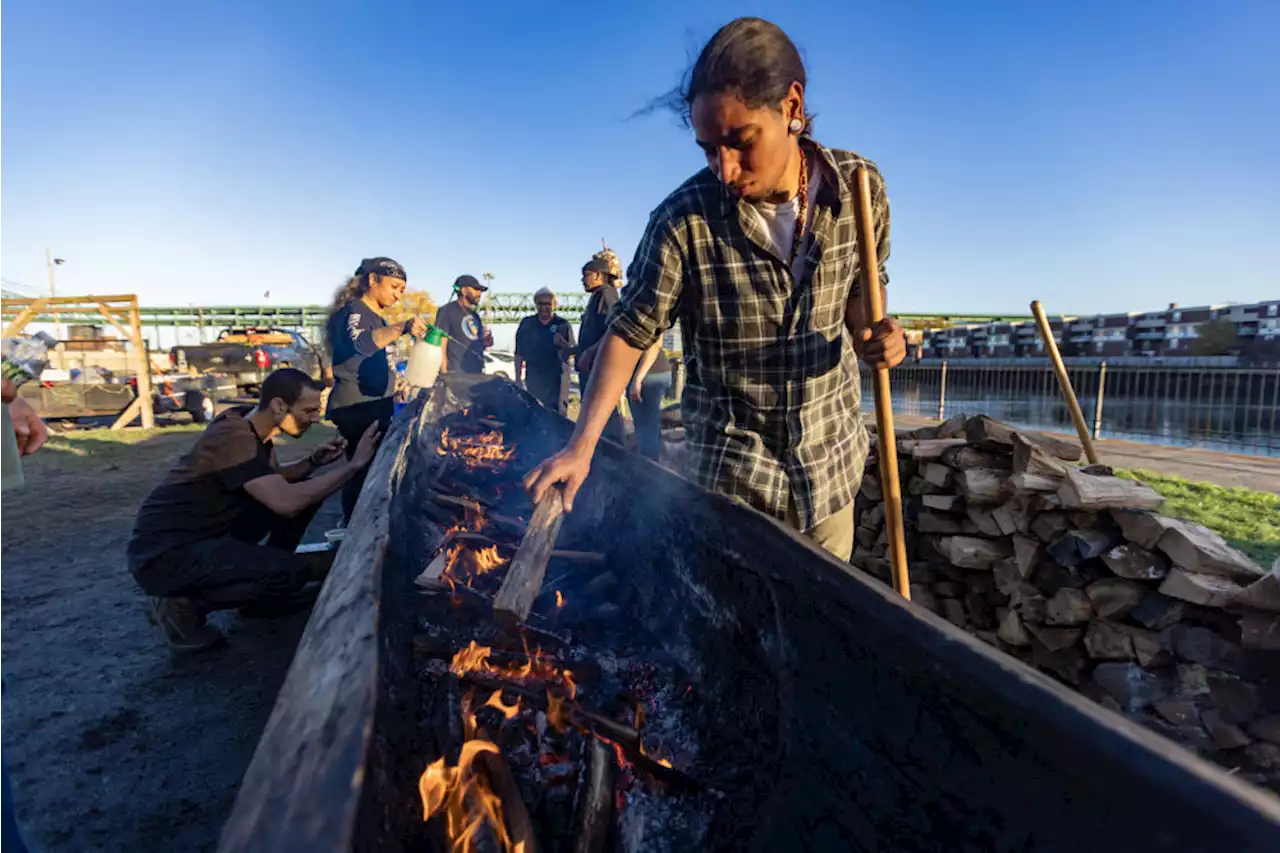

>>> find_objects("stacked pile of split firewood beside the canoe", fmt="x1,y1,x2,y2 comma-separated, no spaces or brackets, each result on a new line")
852,416,1280,792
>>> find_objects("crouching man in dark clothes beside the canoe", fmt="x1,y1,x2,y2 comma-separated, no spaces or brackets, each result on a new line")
128,368,379,649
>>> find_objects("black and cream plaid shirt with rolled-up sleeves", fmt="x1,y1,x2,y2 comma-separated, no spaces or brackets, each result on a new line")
611,140,890,530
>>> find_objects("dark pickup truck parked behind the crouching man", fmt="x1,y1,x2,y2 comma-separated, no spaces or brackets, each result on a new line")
169,328,328,394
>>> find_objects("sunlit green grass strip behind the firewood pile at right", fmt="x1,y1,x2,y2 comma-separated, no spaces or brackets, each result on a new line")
1116,469,1280,569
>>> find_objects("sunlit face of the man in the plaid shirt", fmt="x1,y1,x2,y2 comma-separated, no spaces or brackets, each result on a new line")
690,83,804,201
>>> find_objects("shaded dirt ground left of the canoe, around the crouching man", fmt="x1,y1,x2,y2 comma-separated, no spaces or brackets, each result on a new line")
0,428,339,853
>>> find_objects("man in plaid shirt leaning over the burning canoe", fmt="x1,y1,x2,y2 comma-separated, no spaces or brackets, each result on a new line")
529,18,906,560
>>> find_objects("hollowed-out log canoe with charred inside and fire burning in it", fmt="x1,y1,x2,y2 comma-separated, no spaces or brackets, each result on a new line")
219,377,1280,853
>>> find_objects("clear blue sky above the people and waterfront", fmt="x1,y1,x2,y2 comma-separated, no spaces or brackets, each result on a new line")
0,0,1280,313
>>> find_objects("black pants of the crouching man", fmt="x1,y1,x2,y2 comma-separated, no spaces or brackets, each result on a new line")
133,498,330,611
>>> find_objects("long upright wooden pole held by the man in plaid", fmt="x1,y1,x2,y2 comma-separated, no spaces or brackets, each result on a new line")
855,167,911,601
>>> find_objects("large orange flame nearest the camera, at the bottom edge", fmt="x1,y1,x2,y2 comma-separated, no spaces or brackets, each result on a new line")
417,739,512,853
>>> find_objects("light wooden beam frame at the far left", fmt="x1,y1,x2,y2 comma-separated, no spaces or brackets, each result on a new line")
0,296,155,429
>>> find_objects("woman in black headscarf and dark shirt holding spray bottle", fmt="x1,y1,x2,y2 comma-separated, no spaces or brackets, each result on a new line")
324,257,426,524
